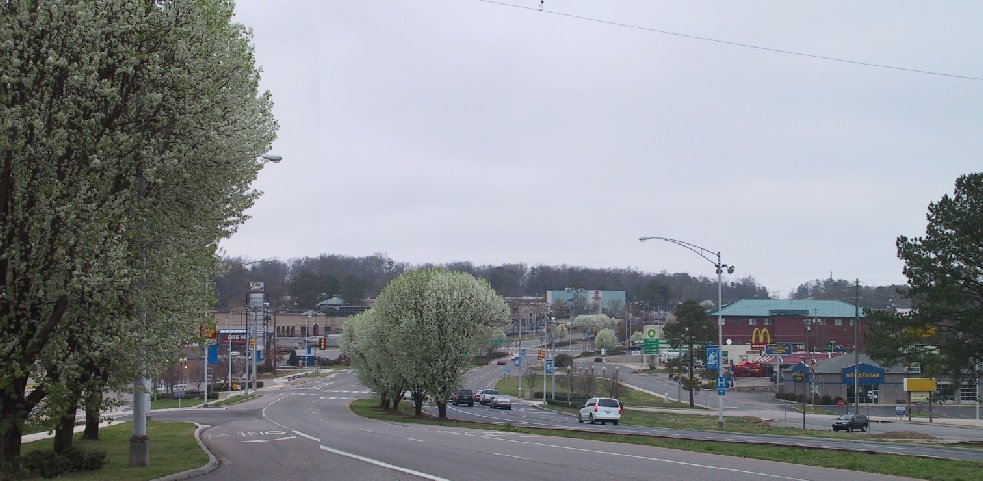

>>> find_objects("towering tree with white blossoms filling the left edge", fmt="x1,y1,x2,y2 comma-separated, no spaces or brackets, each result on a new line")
0,0,276,468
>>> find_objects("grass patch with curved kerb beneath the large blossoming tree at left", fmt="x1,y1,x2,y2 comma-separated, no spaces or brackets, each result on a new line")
22,421,208,481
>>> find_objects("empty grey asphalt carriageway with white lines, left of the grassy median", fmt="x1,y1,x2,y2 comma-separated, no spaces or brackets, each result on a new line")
151,372,932,481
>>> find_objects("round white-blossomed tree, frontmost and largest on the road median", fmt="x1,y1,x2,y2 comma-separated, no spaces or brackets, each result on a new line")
372,269,511,418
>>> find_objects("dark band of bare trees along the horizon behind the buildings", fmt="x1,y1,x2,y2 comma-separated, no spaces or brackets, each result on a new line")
215,254,910,311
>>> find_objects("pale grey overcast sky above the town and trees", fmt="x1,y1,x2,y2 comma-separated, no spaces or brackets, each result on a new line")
222,0,983,296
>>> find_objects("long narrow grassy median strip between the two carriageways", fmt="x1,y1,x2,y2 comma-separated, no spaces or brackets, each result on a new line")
351,399,983,481
